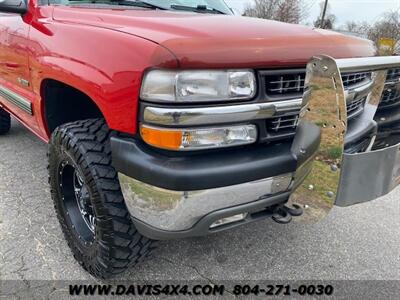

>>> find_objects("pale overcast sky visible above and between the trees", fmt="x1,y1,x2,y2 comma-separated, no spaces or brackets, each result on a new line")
226,0,400,26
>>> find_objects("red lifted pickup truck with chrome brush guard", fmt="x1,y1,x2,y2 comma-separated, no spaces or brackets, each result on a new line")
0,0,400,278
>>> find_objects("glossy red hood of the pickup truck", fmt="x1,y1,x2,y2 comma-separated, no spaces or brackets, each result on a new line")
53,6,375,68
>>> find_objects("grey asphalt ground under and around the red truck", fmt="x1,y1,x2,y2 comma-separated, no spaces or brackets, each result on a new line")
0,121,400,298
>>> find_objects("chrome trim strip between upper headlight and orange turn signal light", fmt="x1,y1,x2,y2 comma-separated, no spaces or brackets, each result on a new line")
144,99,303,126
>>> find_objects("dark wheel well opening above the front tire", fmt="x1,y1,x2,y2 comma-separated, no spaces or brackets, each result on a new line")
42,79,103,134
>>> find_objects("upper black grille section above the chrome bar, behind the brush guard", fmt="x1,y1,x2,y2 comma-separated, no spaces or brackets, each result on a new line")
265,71,372,98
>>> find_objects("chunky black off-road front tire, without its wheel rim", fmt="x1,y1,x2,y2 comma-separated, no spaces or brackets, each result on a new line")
48,119,155,279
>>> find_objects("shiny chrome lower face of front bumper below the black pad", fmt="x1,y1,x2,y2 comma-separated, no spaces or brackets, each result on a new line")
119,174,293,232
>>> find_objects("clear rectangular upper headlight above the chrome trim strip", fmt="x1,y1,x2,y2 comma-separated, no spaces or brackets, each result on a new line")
140,70,256,102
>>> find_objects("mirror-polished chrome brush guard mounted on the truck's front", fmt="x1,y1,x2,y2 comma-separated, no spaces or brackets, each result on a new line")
290,56,400,223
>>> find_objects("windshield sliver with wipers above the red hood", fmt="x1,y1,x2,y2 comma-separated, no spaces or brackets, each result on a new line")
49,0,232,15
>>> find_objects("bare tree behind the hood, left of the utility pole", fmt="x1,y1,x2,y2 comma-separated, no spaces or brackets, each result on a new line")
244,0,308,24
